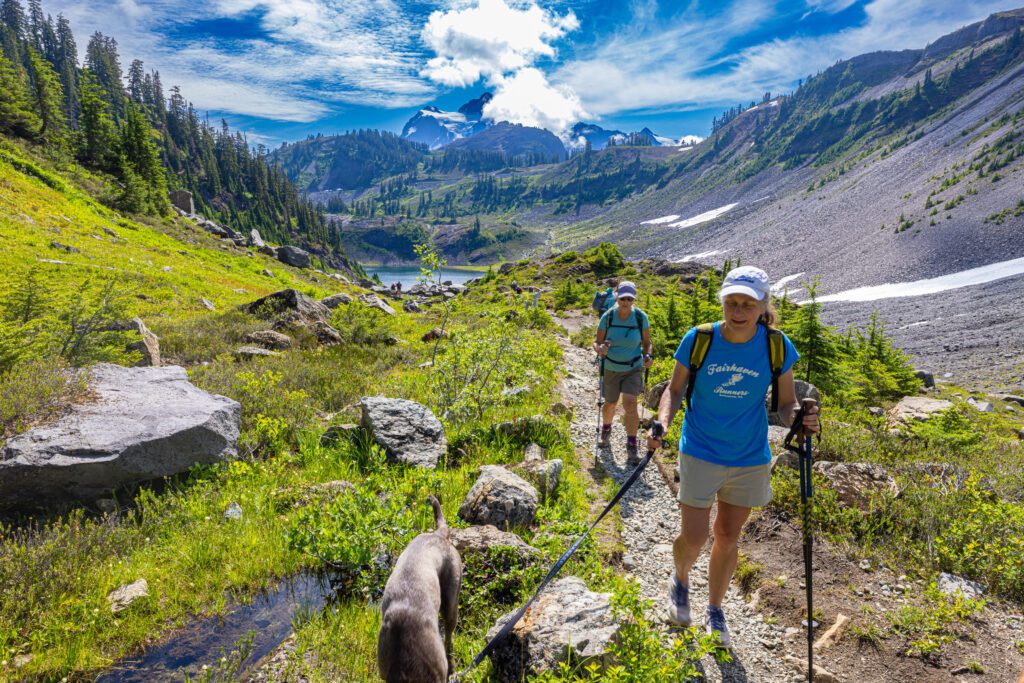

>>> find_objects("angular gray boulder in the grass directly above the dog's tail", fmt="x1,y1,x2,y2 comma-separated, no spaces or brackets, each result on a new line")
359,396,447,469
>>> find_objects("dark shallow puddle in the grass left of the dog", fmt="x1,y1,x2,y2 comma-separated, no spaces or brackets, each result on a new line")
96,573,333,683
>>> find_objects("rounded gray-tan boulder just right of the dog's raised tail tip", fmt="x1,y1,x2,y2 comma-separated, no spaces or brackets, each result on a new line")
459,465,541,530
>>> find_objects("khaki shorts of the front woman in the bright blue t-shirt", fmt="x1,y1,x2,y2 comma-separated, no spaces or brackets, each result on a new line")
679,453,772,508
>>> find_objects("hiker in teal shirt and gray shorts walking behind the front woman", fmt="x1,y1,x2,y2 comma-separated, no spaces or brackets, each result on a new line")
594,282,653,464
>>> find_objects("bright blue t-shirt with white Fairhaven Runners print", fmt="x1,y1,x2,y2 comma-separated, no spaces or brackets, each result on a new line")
673,323,800,467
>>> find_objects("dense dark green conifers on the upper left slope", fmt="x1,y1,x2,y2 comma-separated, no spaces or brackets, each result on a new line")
0,0,341,254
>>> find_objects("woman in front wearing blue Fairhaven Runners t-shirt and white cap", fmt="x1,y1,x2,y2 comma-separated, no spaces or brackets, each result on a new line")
647,266,818,647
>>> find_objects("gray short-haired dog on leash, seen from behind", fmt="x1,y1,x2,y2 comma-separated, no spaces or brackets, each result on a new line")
377,497,462,683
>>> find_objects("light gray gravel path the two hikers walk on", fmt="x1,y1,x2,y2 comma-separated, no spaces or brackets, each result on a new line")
559,338,803,683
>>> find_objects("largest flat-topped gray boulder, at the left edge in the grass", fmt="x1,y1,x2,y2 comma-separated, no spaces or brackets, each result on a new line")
0,364,240,507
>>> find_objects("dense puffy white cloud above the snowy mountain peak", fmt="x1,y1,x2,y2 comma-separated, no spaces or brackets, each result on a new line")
422,0,587,132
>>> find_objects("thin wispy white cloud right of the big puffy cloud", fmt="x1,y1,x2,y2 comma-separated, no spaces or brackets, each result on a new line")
552,0,1013,116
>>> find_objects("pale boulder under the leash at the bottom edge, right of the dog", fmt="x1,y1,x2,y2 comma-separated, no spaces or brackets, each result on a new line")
486,577,623,683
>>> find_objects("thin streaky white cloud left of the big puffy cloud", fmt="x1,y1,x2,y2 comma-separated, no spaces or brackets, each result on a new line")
46,0,436,122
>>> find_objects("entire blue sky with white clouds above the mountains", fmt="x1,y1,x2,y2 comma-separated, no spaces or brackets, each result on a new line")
43,0,1022,146
